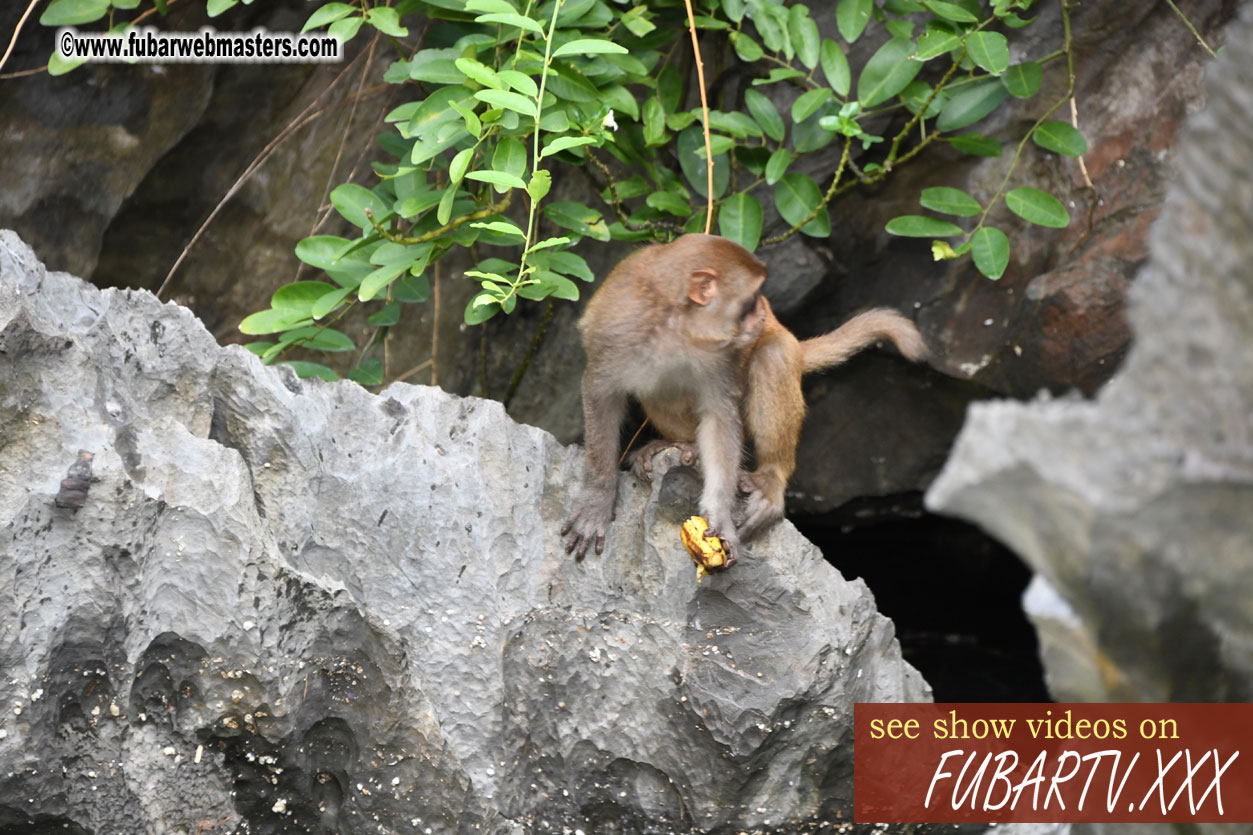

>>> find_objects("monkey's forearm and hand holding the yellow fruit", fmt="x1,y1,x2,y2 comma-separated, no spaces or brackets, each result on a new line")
697,392,744,567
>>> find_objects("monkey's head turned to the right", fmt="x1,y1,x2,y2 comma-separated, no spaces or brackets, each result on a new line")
668,234,767,350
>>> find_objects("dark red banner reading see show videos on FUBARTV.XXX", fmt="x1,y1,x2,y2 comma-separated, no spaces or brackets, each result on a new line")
853,703,1253,824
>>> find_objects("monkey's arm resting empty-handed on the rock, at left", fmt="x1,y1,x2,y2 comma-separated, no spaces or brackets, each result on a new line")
561,369,627,559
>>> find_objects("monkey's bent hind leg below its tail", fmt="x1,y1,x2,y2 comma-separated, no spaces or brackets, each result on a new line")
739,335,804,538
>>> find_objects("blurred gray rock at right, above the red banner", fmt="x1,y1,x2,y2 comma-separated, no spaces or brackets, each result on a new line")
927,6,1253,701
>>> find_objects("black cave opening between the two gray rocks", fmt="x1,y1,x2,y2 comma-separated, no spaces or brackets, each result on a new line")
792,493,1053,702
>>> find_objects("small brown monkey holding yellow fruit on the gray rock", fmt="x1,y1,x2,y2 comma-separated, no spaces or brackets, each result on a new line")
561,234,926,564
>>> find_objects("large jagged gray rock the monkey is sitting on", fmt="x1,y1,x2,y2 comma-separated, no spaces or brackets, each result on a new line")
0,232,930,835
